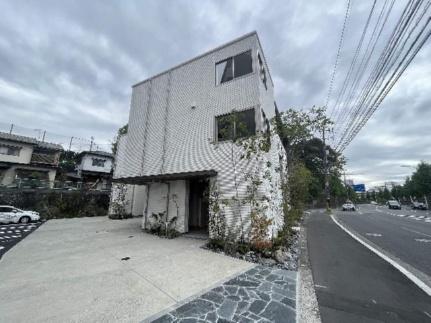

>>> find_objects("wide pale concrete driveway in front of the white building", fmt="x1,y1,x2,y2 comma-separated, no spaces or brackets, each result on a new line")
0,217,253,322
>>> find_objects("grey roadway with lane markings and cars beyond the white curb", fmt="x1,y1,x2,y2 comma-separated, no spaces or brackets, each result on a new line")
337,205,431,284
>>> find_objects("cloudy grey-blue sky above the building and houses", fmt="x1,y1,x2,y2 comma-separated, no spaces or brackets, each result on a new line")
0,0,431,187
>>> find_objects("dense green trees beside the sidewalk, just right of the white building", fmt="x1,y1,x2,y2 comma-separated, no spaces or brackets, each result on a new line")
274,107,355,237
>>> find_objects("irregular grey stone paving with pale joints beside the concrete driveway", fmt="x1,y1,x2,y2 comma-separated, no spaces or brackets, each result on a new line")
153,266,296,323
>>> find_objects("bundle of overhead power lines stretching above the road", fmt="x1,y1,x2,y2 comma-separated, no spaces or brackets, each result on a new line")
331,0,431,151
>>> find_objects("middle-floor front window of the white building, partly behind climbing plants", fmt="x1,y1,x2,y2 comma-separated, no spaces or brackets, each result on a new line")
216,109,256,141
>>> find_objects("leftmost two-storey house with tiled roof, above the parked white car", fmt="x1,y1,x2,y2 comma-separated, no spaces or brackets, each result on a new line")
0,132,63,187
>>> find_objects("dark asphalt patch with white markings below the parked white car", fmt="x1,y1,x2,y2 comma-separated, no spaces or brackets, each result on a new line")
0,222,42,259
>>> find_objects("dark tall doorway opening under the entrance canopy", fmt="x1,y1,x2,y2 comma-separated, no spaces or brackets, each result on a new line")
188,179,209,235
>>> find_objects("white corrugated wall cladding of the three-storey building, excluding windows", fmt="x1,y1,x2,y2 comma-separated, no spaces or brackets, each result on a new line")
114,34,286,240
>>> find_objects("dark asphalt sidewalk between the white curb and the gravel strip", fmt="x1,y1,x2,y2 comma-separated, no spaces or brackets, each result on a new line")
305,212,431,323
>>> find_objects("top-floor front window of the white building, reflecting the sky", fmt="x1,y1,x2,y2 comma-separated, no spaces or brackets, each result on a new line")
216,50,253,85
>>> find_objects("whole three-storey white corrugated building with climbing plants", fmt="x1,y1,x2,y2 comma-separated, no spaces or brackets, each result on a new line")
111,32,285,238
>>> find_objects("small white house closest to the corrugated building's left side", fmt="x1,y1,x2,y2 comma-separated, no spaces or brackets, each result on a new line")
75,151,114,190
